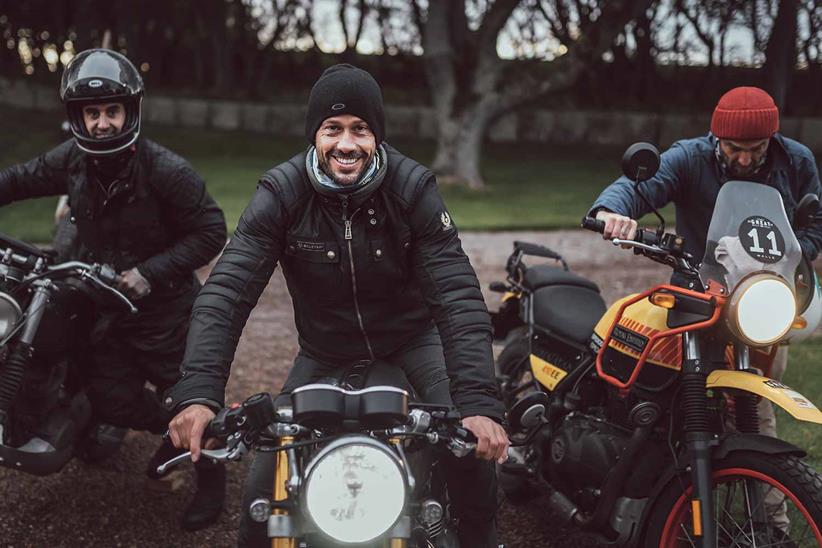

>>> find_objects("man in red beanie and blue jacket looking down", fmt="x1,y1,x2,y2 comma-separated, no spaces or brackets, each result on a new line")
589,82,822,454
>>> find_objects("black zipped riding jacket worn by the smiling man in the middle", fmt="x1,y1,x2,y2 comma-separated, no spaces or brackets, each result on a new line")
166,146,503,420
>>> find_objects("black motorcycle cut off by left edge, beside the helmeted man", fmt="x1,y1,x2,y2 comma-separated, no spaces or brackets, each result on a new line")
0,234,137,475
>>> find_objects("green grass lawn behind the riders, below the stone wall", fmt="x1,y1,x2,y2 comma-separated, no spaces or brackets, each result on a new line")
0,109,673,243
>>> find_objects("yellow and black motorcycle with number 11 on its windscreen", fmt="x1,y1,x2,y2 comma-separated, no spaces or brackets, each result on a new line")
494,144,822,548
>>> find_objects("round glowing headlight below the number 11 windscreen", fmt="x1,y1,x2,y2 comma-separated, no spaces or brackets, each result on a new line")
729,274,796,345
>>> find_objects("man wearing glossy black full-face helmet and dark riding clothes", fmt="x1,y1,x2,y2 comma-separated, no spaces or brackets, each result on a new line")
0,49,226,529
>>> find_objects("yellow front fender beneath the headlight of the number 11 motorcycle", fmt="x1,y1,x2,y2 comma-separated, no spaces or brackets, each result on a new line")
706,370,822,424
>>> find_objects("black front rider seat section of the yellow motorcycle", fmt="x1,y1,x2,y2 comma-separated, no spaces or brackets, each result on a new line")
534,285,605,345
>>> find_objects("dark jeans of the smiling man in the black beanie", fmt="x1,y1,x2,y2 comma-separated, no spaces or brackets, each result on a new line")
238,330,497,548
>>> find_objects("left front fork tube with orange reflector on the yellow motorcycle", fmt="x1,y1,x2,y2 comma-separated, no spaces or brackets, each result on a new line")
682,332,716,548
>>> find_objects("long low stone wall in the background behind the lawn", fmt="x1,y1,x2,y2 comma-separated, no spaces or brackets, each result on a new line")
0,79,822,153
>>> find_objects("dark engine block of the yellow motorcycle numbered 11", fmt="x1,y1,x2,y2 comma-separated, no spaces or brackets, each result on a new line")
543,413,630,498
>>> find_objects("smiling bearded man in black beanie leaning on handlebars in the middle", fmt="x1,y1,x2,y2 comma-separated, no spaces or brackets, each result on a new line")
166,64,508,548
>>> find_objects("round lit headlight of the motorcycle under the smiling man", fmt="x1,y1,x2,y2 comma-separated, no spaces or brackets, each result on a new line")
303,437,405,544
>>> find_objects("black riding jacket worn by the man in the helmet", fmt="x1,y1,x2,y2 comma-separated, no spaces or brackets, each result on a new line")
0,139,226,304
